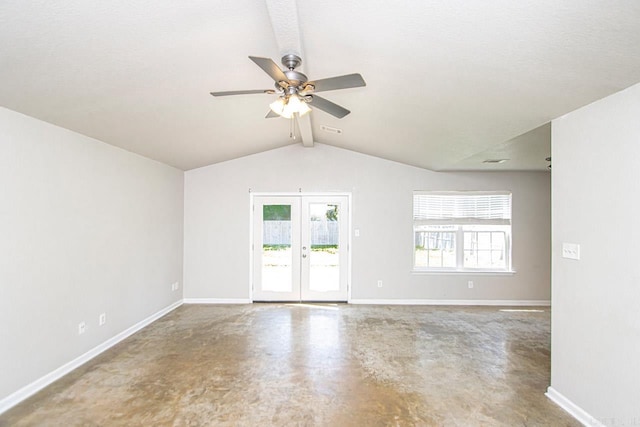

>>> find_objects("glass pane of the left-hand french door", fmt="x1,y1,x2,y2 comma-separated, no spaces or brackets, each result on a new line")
262,205,293,292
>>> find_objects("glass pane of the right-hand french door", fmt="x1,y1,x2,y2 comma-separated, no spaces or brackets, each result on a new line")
308,203,340,292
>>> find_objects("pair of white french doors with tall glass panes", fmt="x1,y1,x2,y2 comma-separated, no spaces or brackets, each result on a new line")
251,195,349,301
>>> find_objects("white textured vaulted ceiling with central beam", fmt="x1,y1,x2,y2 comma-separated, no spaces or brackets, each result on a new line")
0,0,640,170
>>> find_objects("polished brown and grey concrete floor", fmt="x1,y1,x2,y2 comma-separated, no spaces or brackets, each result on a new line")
0,304,580,426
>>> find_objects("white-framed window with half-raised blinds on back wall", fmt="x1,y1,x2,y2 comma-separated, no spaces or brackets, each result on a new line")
413,191,511,272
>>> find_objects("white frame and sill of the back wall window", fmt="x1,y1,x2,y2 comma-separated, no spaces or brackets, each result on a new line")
411,191,514,275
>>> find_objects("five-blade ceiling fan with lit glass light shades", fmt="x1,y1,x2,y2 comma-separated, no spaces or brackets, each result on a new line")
211,55,366,119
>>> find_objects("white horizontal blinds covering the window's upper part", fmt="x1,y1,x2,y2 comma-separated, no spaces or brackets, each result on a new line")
413,191,511,225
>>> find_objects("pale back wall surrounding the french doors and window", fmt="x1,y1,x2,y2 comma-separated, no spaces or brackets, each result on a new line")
184,144,551,301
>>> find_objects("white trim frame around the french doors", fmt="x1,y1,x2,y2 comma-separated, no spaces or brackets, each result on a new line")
247,190,352,303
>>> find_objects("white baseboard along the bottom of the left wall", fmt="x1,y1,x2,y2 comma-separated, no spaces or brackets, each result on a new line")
0,300,182,414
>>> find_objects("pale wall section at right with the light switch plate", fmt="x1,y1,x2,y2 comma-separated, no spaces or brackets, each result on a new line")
551,85,640,426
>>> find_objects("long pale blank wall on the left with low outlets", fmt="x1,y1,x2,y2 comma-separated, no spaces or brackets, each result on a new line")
0,108,184,401
